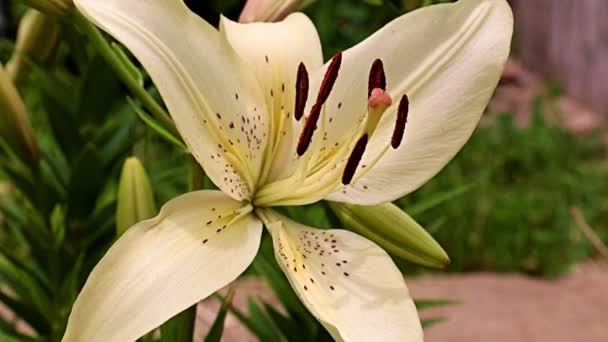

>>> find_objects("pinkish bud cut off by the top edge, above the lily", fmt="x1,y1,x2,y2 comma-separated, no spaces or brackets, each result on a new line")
239,0,305,23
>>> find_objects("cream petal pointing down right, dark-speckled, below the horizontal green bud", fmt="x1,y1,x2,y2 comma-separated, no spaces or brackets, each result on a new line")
264,210,423,342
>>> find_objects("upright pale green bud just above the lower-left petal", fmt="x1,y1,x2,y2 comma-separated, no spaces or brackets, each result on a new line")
116,157,156,236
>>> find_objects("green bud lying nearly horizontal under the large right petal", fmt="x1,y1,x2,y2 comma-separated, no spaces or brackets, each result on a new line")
328,202,450,268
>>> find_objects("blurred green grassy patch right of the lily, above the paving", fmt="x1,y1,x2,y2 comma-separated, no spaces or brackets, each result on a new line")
398,102,608,276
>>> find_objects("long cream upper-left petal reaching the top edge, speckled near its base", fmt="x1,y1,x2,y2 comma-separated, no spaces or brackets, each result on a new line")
75,0,268,199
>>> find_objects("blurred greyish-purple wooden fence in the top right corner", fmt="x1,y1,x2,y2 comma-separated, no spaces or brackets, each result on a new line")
510,0,608,118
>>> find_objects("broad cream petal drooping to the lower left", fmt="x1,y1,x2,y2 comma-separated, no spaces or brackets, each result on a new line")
63,191,262,342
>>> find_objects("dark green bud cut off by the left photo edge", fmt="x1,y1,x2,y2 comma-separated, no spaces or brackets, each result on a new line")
0,65,40,165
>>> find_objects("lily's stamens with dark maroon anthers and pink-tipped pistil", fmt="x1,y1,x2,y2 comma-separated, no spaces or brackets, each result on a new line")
254,53,409,206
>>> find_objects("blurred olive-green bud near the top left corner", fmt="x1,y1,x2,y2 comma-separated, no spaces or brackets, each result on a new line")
6,9,59,84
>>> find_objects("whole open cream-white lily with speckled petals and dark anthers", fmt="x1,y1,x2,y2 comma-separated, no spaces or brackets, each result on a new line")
64,0,513,341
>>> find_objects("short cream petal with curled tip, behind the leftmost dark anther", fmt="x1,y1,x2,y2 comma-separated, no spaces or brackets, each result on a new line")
220,13,323,180
